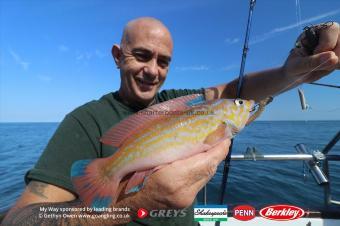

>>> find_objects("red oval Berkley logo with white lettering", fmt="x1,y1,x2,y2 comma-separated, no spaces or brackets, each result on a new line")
259,205,305,221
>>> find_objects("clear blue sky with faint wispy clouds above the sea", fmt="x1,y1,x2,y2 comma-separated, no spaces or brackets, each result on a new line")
0,0,340,122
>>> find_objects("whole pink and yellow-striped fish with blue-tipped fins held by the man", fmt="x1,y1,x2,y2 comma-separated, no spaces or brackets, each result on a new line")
71,94,254,208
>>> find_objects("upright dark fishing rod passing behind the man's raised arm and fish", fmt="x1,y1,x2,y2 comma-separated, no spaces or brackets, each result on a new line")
217,0,256,209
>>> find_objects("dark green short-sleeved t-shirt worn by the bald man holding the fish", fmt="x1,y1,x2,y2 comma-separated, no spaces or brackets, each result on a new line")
25,89,204,226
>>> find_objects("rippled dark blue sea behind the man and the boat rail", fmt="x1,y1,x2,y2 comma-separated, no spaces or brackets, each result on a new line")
0,121,340,213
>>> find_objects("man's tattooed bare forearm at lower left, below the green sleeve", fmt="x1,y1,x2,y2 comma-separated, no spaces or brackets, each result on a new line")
2,181,133,226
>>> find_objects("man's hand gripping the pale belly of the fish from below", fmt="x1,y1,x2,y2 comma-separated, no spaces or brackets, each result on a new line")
130,139,230,209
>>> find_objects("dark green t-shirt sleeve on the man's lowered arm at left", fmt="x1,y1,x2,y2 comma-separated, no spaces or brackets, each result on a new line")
25,114,99,193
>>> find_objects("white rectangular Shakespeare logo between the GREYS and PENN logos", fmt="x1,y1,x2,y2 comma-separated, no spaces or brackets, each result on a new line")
194,205,228,221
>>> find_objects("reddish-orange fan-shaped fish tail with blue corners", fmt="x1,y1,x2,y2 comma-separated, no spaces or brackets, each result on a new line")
71,159,120,208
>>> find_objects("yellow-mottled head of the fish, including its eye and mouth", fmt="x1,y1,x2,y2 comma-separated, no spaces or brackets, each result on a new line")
223,99,255,136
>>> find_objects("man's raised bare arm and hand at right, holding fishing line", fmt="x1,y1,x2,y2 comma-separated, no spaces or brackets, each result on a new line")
205,22,340,101
